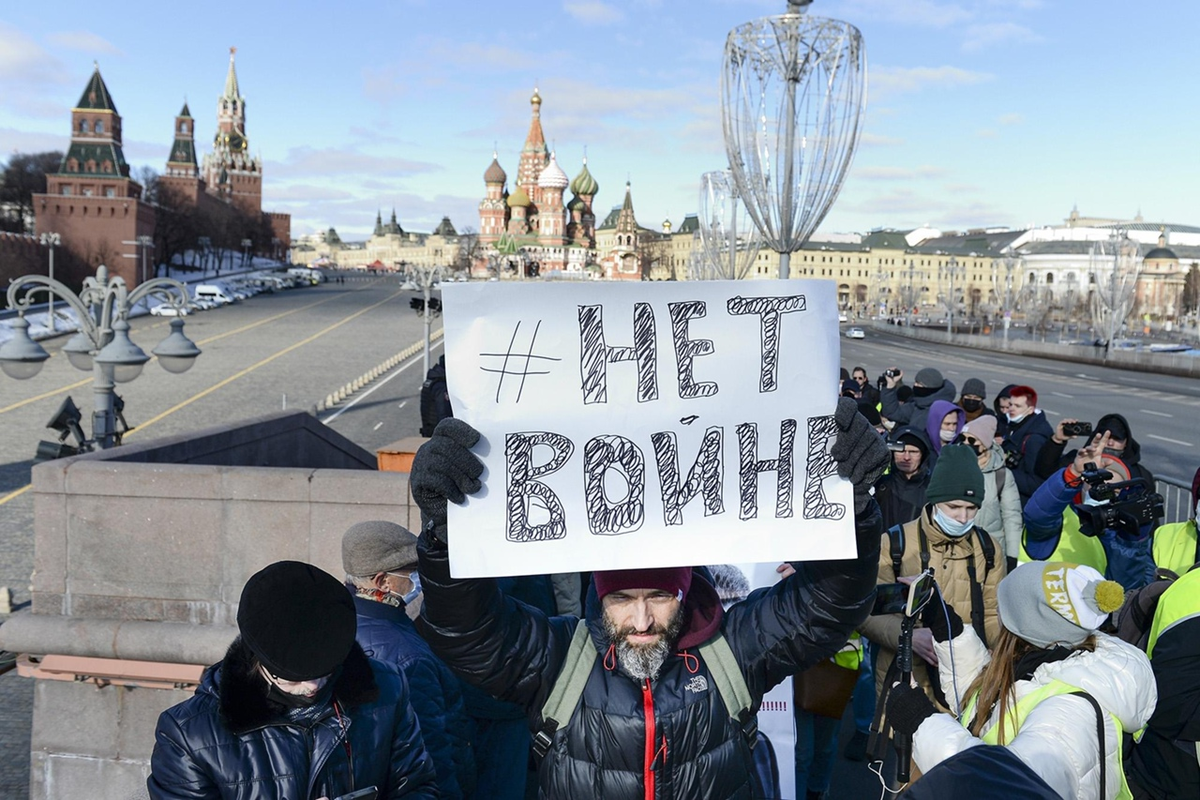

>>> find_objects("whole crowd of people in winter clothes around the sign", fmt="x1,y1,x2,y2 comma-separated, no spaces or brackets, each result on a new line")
148,357,1200,800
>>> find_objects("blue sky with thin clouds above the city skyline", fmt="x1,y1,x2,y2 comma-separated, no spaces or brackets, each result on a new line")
0,0,1200,239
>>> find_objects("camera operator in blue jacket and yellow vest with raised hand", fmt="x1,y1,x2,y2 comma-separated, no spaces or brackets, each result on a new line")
1019,432,1162,591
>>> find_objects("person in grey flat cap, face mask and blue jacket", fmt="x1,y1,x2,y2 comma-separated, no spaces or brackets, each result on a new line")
342,521,475,798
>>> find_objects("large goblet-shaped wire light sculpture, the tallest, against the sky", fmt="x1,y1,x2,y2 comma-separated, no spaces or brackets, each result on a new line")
721,0,866,278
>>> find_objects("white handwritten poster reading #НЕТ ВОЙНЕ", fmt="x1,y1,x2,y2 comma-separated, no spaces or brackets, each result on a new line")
443,281,854,577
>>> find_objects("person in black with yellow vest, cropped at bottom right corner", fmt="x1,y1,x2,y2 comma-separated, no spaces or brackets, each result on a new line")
1128,566,1200,800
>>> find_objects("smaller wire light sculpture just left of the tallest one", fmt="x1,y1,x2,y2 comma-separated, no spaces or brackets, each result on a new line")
700,169,762,281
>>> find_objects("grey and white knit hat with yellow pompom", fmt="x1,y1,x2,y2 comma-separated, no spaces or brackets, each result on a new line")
993,561,1124,648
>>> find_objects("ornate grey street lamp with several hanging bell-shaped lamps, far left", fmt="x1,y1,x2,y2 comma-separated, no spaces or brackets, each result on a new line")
0,264,200,450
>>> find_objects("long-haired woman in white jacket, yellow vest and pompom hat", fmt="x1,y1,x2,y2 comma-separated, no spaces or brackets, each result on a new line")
888,561,1158,800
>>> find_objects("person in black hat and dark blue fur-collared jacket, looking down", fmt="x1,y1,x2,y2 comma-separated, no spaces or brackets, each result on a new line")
146,561,438,800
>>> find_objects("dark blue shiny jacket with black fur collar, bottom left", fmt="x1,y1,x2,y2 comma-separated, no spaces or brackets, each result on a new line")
146,637,438,800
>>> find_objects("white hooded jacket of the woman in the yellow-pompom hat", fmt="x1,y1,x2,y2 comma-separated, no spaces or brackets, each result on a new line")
912,626,1158,800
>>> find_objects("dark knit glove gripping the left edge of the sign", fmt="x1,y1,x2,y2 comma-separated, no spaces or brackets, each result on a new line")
408,417,484,542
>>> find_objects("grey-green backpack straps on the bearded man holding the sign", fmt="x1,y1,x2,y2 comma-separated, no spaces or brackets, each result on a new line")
533,619,758,758
